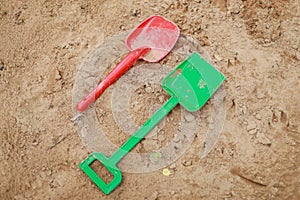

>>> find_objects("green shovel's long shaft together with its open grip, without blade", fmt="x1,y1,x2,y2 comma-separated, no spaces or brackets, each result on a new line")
79,97,178,194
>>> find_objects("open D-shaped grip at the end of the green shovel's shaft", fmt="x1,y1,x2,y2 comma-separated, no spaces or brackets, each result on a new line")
79,152,122,194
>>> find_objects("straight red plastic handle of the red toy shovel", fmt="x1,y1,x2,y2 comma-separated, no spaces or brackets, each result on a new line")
76,47,150,112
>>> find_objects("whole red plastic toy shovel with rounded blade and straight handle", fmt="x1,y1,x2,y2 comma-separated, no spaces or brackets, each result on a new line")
76,16,179,112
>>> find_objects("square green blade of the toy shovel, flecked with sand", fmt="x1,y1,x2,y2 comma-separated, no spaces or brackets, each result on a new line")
162,52,225,112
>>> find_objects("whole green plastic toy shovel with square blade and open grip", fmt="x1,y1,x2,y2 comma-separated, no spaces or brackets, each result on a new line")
79,53,225,194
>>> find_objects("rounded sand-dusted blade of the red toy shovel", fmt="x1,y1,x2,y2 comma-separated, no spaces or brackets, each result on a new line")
125,16,180,62
